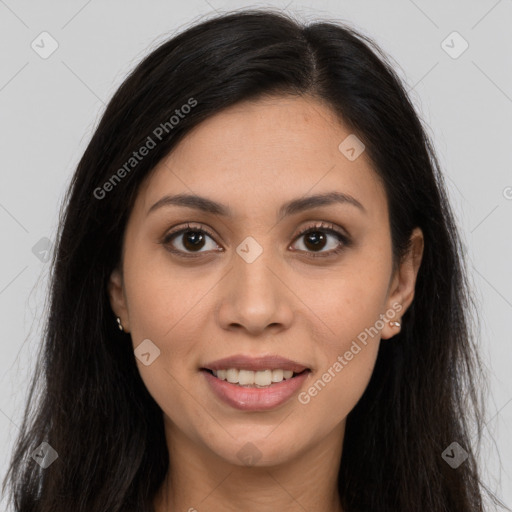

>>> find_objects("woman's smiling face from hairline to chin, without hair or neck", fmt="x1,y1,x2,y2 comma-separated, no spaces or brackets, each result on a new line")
109,97,422,465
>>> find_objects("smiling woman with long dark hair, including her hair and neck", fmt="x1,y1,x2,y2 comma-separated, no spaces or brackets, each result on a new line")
4,11,504,512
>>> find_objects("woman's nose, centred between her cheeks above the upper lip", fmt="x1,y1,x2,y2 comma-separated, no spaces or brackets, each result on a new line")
217,246,296,336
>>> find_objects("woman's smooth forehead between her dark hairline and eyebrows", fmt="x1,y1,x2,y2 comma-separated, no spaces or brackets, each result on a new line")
134,97,387,222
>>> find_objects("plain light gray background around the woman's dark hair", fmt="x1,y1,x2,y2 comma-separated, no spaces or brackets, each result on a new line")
0,0,512,509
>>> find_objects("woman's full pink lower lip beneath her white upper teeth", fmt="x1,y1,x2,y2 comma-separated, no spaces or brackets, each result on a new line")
202,370,310,411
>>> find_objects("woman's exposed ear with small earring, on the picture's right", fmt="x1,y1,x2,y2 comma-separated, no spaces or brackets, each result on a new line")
381,227,424,339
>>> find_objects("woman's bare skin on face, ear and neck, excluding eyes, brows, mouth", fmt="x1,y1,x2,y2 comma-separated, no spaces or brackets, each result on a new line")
109,96,423,512
